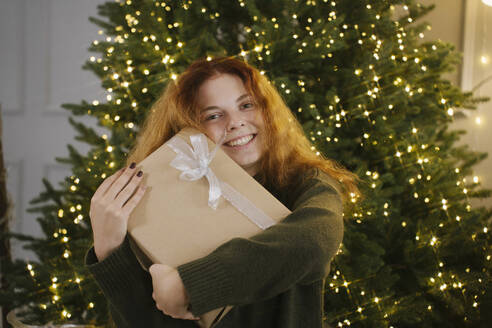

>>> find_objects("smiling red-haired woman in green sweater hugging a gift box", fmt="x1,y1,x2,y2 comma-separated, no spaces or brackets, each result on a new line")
86,57,357,328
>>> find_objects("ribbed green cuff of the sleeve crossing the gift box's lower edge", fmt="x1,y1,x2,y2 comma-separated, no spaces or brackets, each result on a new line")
177,253,233,316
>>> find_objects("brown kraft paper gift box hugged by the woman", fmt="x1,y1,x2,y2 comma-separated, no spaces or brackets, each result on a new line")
128,128,290,328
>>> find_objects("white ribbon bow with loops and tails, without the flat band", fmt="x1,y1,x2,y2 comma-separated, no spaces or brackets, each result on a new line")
168,134,226,210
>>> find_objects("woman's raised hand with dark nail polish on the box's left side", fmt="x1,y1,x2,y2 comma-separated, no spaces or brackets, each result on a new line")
89,163,147,261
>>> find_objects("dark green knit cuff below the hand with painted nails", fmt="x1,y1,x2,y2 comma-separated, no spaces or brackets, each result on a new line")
85,238,145,298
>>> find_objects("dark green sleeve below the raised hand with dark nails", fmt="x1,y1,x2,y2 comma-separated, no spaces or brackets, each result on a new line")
85,237,197,328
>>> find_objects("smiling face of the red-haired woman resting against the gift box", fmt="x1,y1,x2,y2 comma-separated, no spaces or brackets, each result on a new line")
198,74,264,176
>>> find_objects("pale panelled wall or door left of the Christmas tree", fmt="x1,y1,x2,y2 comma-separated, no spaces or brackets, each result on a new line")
0,0,105,259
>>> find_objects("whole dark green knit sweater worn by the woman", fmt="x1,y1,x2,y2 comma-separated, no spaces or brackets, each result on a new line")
86,170,343,328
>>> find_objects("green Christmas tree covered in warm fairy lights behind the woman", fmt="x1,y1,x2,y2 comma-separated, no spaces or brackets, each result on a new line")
2,0,492,327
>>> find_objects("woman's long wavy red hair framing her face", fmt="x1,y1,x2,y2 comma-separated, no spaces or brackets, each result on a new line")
127,57,359,199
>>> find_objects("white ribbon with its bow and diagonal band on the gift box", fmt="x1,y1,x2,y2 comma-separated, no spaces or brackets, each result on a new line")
166,133,275,229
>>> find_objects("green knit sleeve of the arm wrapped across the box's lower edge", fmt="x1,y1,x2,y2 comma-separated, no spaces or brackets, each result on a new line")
177,177,343,316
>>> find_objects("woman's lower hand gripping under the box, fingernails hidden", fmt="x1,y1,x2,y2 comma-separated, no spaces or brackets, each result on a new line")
149,264,200,320
